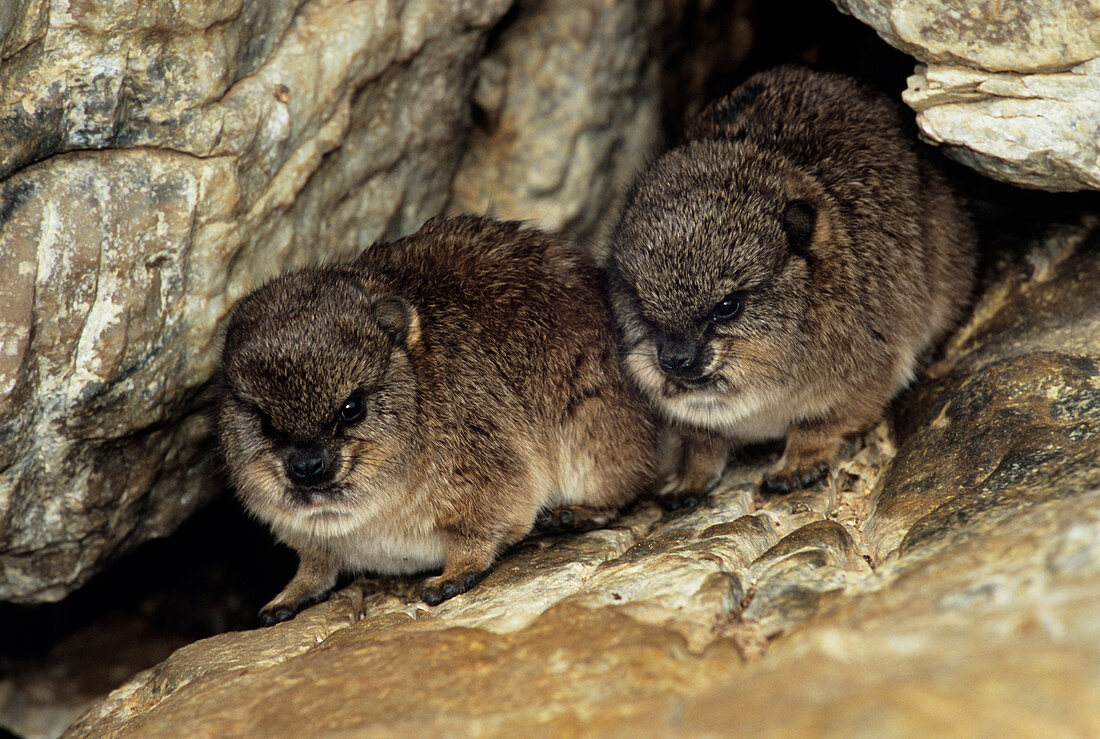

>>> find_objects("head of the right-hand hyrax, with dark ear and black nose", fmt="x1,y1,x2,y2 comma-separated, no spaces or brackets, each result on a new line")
608,140,829,424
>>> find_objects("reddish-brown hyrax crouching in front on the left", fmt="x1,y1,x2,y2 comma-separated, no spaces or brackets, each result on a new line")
219,217,656,624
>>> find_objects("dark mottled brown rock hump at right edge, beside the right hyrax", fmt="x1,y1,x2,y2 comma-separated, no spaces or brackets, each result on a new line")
866,219,1100,560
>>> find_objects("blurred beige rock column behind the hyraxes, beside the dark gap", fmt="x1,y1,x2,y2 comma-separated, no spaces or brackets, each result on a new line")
451,0,662,243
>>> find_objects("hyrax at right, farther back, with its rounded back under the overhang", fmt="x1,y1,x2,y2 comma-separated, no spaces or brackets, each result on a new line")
608,68,975,503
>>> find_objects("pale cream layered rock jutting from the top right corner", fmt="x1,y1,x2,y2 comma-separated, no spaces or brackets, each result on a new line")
834,0,1100,191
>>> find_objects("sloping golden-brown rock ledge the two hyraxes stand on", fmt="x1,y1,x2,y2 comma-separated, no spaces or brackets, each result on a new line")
69,223,1100,736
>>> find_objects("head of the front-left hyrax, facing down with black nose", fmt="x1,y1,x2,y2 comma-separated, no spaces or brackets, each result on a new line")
218,267,419,528
